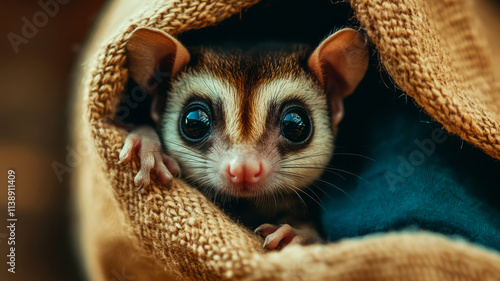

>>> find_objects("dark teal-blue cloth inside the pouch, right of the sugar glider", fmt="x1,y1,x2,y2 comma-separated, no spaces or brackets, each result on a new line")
315,78,500,250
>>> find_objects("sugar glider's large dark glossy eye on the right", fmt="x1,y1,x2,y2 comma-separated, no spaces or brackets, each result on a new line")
281,107,312,143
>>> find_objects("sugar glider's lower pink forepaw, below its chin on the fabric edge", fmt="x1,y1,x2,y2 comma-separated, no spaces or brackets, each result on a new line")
255,223,315,250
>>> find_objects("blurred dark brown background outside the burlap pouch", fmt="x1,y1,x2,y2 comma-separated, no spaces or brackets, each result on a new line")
0,0,500,280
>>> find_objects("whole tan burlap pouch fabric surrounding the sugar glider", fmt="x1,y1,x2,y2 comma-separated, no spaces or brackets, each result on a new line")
73,0,500,281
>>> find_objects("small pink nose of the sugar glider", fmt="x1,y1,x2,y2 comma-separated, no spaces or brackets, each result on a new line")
226,158,264,184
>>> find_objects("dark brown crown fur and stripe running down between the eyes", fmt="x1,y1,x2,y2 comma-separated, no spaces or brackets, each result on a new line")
187,45,320,141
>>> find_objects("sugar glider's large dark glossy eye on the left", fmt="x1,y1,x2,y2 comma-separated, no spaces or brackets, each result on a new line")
180,104,212,141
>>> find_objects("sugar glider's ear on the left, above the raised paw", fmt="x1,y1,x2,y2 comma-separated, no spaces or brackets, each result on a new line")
127,28,190,122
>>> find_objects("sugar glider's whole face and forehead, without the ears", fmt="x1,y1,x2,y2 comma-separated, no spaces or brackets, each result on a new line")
161,47,334,197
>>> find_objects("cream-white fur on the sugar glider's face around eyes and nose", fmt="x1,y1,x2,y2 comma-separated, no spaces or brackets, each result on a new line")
161,68,334,197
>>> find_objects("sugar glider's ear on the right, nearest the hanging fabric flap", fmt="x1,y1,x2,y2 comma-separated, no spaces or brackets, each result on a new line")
308,28,369,125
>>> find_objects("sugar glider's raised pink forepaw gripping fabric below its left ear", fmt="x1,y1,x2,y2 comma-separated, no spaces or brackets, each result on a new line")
118,127,179,190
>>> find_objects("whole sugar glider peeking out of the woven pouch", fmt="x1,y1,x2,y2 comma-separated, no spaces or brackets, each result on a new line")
120,28,369,249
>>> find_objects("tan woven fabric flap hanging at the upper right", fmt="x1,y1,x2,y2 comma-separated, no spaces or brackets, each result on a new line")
352,0,500,159
